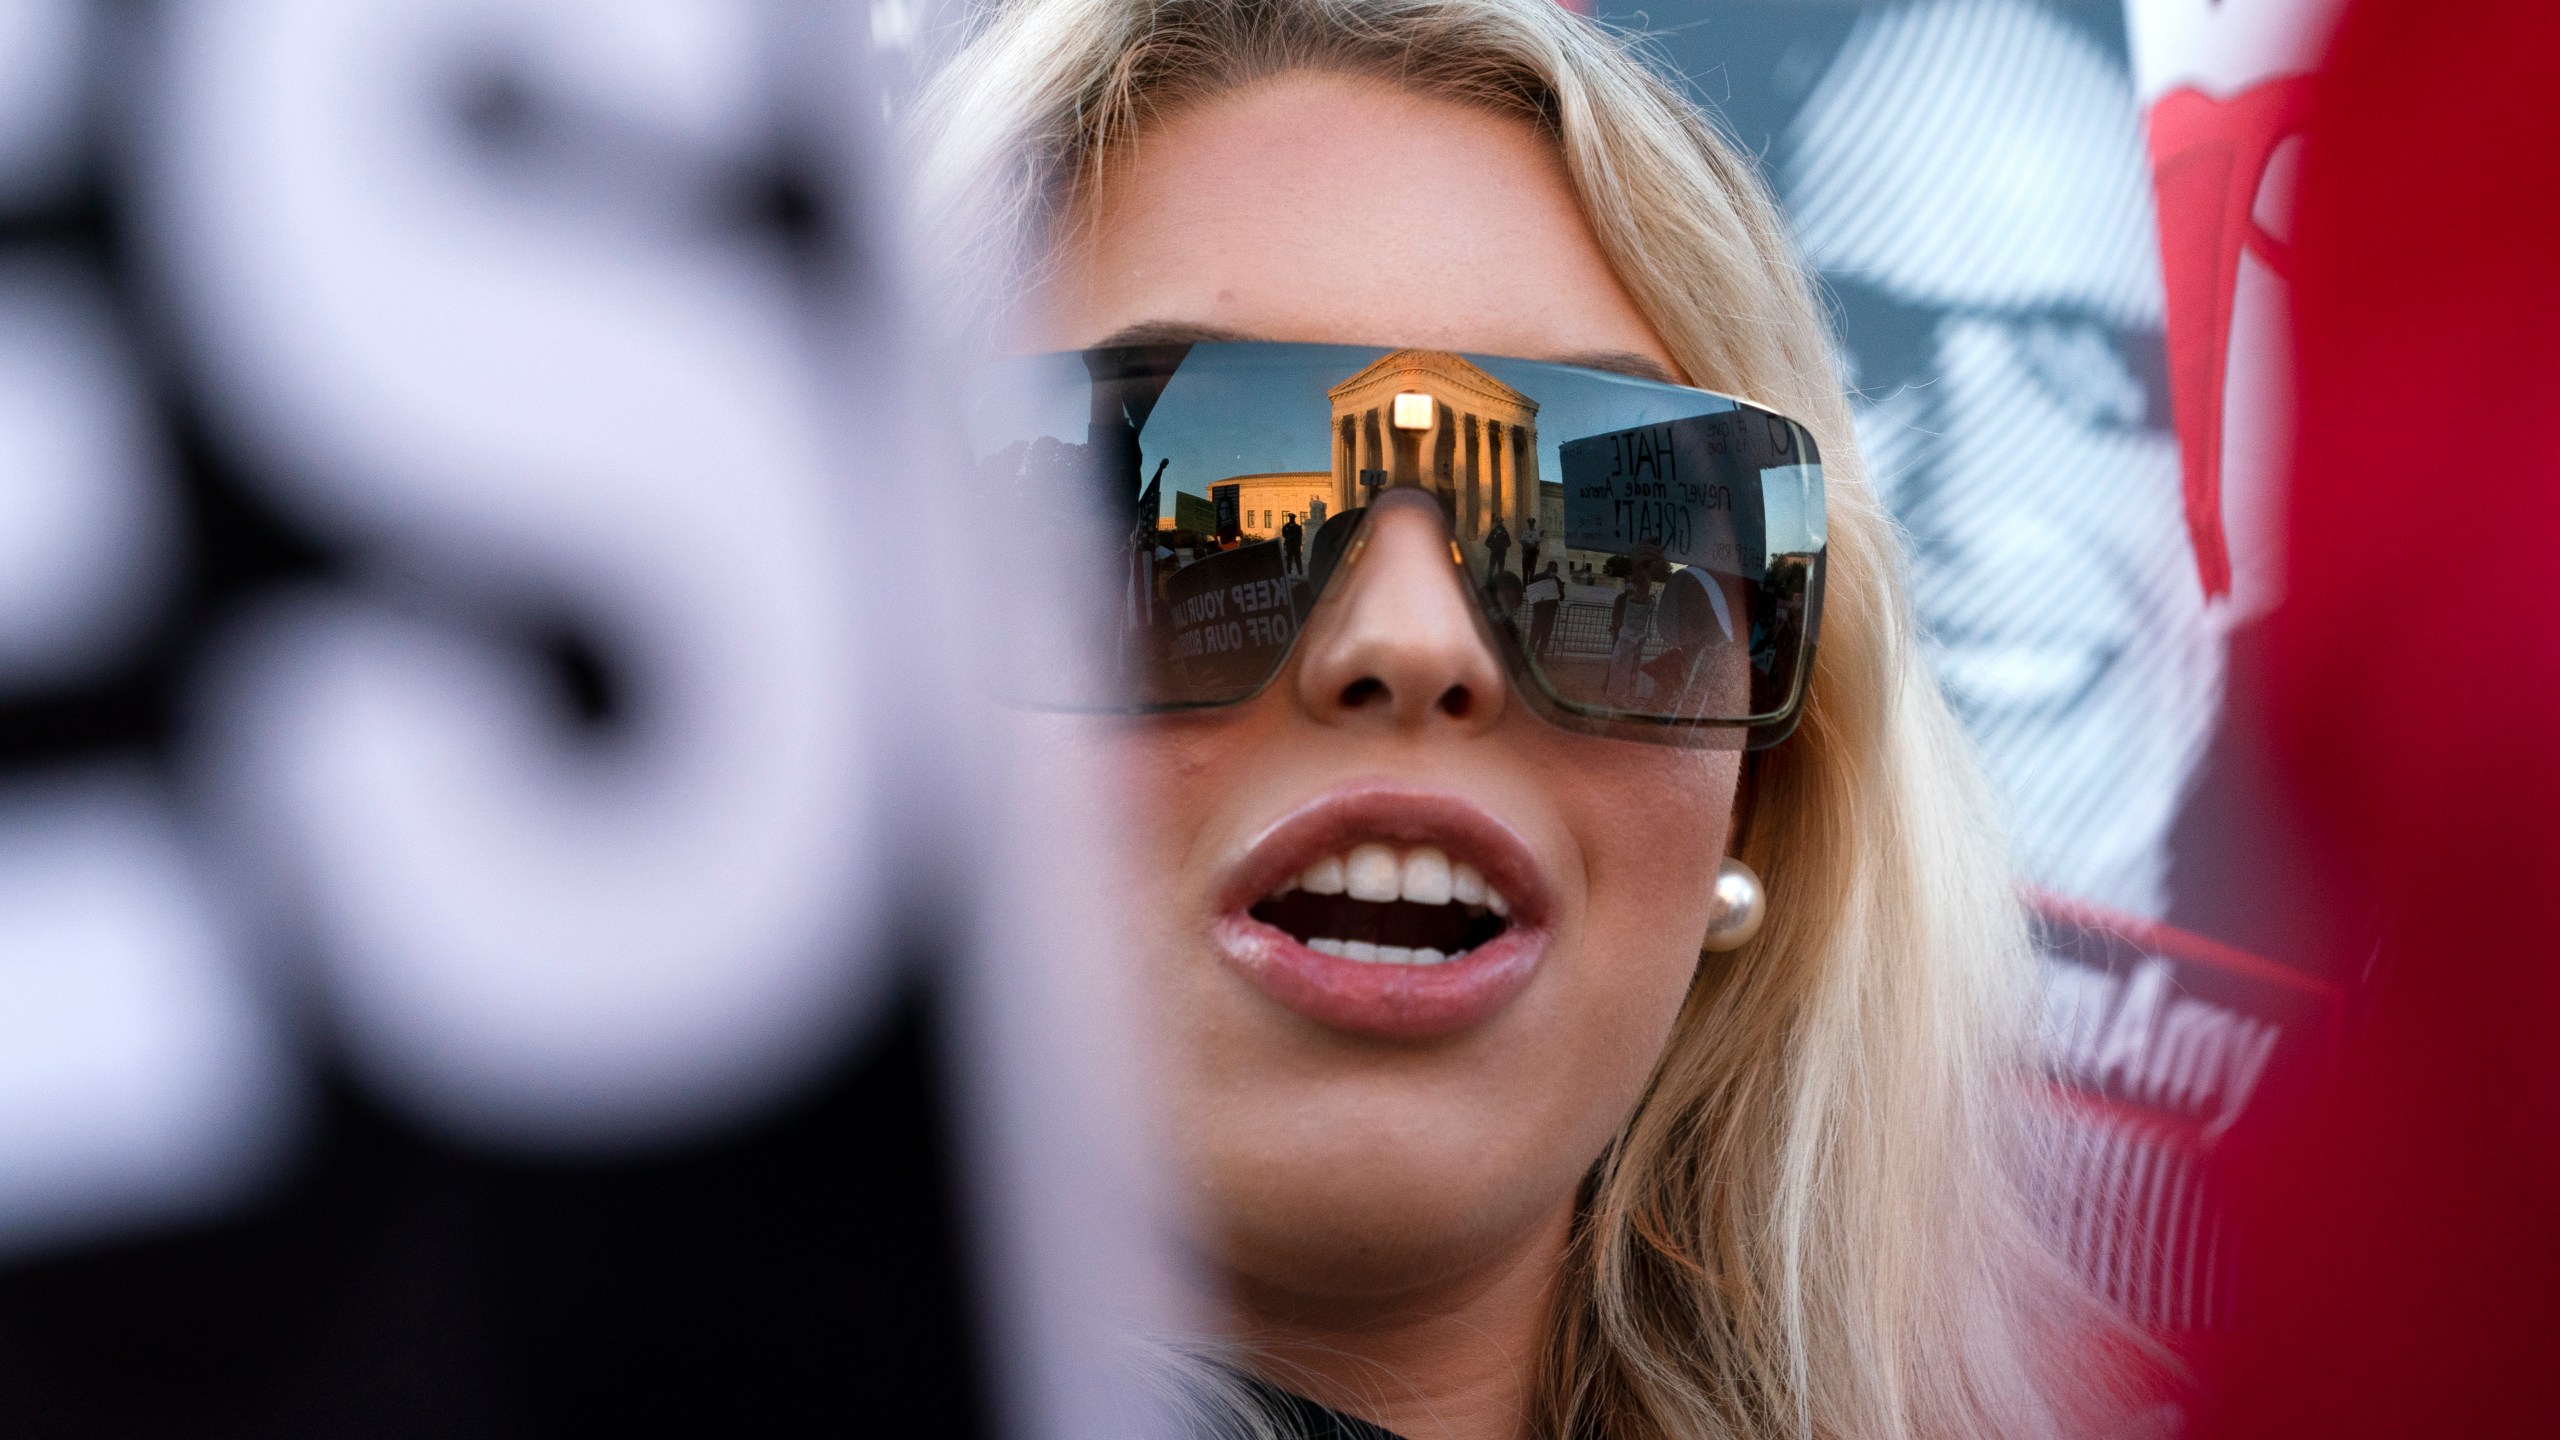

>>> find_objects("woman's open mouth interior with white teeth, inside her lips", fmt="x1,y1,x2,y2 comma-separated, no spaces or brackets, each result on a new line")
1249,840,1510,966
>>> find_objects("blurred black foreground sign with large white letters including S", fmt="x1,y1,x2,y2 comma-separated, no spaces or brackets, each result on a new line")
0,0,986,1435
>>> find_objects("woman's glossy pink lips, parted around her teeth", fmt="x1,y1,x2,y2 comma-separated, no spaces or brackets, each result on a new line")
1213,787,1549,1040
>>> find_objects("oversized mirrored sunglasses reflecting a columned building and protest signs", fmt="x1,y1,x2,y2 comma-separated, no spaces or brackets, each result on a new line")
968,341,1825,748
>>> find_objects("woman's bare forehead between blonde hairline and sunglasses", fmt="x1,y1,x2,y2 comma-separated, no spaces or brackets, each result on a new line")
1037,72,1677,374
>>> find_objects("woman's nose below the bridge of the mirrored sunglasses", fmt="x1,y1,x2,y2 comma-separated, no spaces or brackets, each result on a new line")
1298,492,1510,735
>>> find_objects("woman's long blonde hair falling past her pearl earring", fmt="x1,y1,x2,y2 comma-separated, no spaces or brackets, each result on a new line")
916,0,2143,1440
